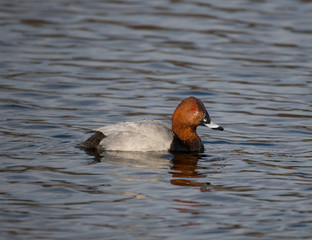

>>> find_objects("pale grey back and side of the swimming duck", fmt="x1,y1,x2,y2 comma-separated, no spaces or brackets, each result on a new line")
96,120,173,152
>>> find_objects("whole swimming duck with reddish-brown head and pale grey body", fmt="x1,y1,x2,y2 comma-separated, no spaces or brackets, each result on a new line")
79,96,224,153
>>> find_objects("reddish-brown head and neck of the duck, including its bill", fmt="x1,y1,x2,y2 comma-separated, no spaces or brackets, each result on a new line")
172,97,223,151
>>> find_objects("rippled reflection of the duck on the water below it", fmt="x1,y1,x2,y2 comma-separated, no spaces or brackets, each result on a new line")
86,150,214,191
